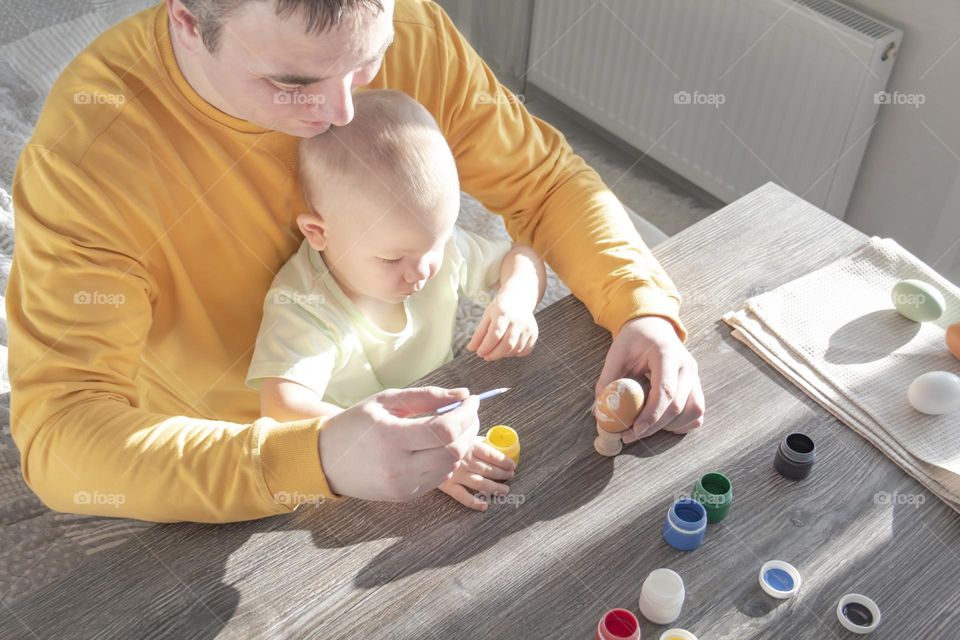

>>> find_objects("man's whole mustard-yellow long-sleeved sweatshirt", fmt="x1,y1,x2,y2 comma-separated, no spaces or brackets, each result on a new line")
7,0,685,522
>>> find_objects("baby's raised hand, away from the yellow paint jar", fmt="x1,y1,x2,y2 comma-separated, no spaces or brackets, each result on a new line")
467,296,539,362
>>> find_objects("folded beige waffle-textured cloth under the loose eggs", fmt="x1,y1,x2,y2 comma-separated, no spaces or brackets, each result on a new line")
723,238,960,511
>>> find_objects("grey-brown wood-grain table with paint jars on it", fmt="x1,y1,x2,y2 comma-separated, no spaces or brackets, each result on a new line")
0,184,960,640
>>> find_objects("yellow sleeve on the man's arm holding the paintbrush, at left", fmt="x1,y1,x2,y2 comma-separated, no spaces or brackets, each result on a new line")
7,146,335,522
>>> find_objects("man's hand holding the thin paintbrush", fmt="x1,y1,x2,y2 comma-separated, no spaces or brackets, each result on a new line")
319,387,480,501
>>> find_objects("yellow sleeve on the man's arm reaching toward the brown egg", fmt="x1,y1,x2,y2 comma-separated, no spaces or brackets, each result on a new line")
435,2,686,339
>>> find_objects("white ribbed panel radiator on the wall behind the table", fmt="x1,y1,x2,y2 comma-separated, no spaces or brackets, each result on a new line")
528,0,909,218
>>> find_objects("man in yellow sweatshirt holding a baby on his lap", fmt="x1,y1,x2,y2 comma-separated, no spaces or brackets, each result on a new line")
7,0,704,522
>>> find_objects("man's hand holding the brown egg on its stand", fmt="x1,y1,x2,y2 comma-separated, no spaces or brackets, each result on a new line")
595,316,704,443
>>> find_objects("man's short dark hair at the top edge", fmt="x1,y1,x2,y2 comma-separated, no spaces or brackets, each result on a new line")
181,0,383,53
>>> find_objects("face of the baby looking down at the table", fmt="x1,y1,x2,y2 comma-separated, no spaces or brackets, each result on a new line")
323,188,460,304
